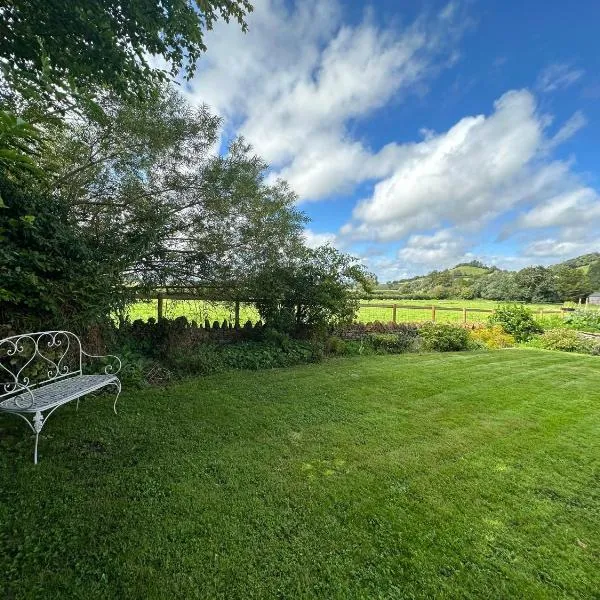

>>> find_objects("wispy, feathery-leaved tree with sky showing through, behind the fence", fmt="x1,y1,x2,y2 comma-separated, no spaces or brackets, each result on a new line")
48,91,306,295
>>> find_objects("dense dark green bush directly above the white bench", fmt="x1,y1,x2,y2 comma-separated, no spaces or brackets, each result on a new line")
0,172,124,330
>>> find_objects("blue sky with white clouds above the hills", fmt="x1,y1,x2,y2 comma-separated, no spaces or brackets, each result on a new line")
182,0,600,281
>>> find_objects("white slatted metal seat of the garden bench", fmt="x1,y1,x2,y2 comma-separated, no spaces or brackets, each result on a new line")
0,375,119,413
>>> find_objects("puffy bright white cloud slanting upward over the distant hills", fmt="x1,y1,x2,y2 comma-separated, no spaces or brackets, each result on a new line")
343,90,543,241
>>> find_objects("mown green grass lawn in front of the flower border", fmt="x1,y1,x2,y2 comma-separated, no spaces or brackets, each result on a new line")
0,349,600,600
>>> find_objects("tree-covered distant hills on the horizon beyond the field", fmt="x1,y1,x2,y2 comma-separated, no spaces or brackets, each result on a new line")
373,252,600,302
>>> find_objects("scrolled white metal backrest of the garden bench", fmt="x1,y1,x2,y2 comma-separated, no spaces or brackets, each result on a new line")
0,331,82,400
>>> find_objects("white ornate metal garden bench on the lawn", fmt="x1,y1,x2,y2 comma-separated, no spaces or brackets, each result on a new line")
0,331,121,464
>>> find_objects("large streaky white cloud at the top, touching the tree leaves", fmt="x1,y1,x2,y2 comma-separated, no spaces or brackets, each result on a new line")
188,0,464,200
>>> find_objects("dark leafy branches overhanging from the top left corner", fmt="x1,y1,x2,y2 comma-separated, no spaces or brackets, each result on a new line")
0,0,252,112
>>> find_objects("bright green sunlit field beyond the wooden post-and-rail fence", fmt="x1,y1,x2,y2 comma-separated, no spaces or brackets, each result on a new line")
129,299,572,324
